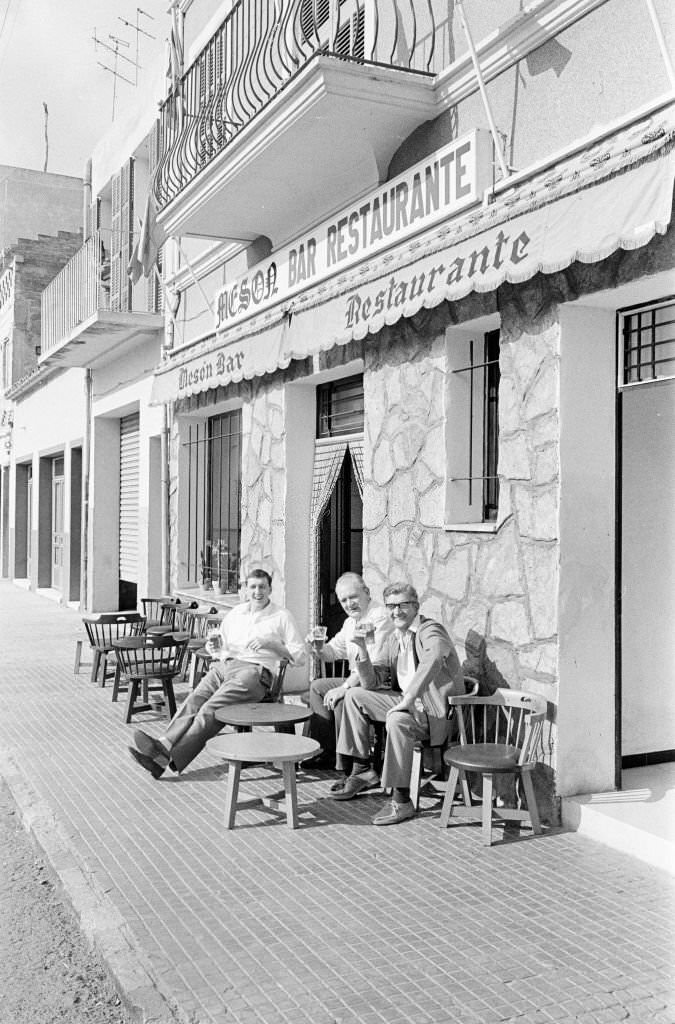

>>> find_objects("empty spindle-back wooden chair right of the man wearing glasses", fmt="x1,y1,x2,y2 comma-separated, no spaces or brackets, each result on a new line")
440,689,546,846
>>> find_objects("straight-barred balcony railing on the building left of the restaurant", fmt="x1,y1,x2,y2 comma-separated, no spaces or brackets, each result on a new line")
41,228,158,356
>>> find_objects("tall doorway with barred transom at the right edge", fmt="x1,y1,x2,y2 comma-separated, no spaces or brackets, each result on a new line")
619,303,675,768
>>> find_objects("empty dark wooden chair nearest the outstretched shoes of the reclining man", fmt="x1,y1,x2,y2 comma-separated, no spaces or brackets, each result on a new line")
113,633,188,722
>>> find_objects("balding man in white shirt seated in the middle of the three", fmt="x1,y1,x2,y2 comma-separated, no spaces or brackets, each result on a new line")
306,572,393,768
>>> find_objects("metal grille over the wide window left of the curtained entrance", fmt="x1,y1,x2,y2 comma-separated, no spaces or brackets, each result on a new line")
184,410,242,594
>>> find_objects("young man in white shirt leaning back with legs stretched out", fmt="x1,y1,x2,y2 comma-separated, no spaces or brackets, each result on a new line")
129,569,305,778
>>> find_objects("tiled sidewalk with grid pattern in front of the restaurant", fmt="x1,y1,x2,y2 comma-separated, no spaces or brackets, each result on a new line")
0,583,675,1024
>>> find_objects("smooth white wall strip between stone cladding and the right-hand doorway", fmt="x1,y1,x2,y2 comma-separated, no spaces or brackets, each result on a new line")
556,305,616,797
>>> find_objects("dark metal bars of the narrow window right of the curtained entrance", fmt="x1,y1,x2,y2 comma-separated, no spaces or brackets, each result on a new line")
453,330,500,522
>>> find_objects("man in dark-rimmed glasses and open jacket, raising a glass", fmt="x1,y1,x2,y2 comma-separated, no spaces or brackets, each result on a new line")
331,583,465,825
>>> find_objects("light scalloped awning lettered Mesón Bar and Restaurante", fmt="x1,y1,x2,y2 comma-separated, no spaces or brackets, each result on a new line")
153,113,675,402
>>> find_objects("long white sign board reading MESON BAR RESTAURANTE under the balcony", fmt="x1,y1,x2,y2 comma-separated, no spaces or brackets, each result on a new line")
215,129,492,332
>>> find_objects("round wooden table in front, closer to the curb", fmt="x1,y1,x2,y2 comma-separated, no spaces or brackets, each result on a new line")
209,732,321,828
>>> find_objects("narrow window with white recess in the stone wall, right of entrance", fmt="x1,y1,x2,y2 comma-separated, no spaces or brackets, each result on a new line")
446,330,500,525
